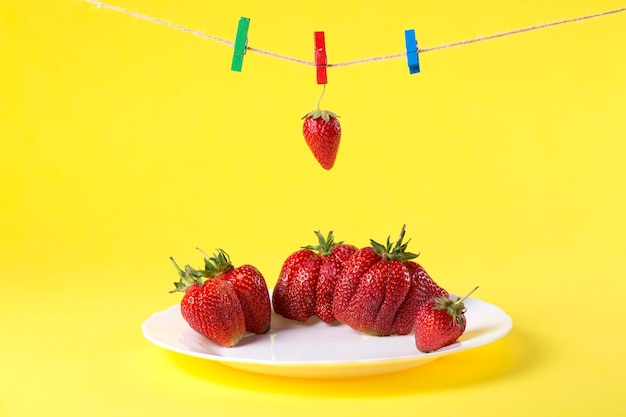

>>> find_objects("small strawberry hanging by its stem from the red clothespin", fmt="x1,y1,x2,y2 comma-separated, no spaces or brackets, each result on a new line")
302,107,341,169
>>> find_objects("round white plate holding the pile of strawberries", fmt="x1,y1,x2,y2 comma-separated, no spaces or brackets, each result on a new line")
141,292,513,378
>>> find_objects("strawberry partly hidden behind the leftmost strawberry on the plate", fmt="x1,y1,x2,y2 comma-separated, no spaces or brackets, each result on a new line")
198,249,272,334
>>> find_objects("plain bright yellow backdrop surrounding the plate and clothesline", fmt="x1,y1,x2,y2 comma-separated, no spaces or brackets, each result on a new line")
0,0,626,417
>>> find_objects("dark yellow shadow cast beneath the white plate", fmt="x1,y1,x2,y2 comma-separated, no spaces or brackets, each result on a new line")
168,327,542,398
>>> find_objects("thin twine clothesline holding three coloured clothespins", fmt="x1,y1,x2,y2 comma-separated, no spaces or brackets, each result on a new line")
85,0,626,67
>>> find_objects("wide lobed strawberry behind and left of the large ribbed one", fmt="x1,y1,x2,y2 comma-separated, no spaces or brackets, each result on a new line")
272,231,357,323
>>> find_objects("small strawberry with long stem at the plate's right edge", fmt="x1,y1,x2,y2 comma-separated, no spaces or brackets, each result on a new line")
414,287,478,352
